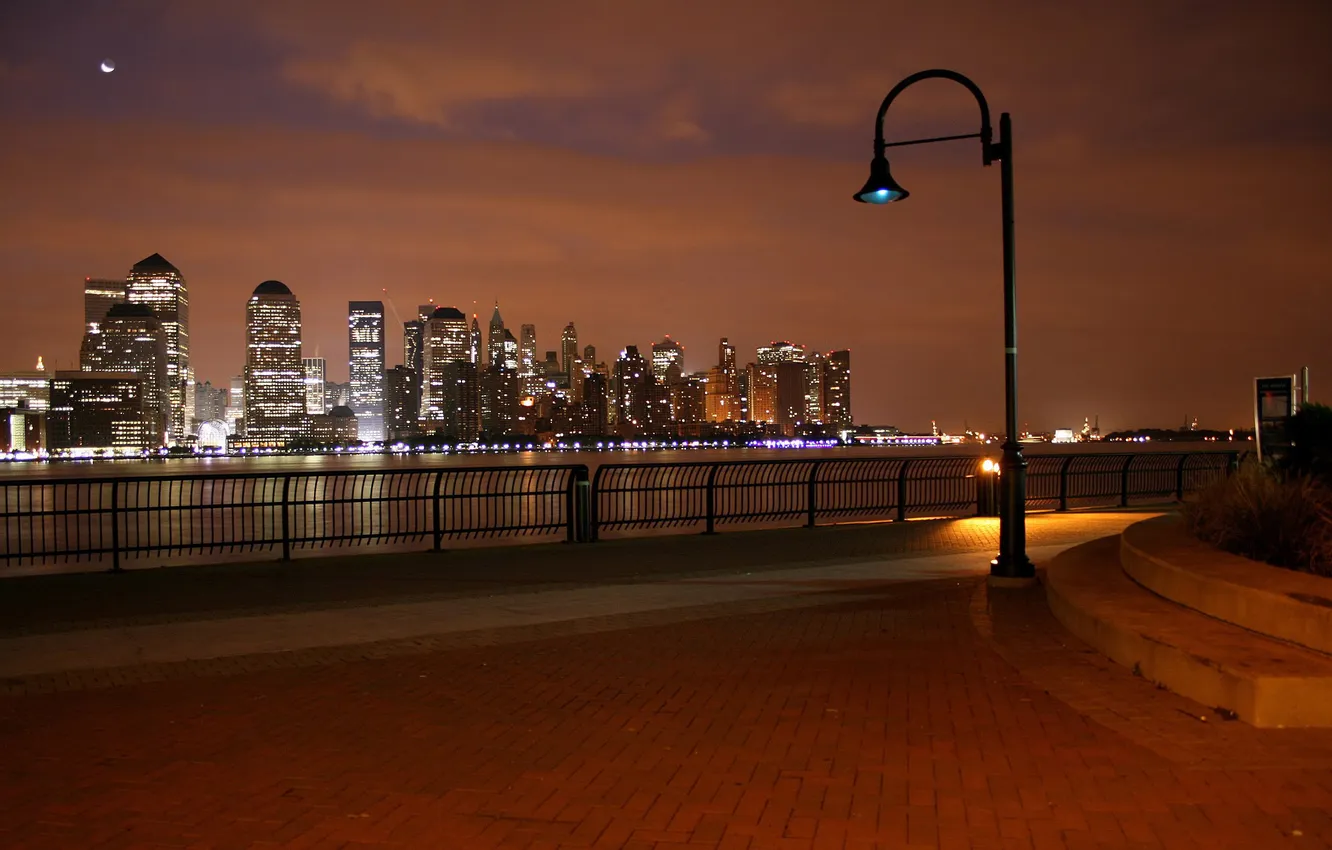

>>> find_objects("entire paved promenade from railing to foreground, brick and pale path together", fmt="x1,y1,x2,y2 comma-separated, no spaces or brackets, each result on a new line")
0,514,1332,850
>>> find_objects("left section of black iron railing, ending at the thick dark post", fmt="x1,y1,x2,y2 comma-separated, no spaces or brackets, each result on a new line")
0,464,587,569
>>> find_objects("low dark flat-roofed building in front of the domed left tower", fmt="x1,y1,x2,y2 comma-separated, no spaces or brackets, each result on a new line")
47,370,144,453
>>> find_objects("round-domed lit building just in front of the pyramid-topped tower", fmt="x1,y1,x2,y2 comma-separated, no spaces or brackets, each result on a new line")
79,302,170,448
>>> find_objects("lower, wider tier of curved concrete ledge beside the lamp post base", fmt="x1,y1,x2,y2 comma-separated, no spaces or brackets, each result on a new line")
1046,537,1332,726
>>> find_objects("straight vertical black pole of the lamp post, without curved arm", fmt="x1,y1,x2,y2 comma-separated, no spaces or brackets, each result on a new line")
990,112,1036,578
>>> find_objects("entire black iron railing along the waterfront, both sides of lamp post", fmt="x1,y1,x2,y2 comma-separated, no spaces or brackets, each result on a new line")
0,452,1239,569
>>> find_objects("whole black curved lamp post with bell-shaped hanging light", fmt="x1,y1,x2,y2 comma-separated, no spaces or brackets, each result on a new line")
852,68,1035,580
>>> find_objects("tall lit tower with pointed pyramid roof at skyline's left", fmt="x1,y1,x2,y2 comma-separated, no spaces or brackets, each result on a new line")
125,253,192,445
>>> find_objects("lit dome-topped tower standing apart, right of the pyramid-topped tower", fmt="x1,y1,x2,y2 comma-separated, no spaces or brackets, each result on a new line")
245,280,306,446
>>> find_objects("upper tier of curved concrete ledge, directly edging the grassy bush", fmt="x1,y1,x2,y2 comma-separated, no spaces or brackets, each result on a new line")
1119,517,1332,653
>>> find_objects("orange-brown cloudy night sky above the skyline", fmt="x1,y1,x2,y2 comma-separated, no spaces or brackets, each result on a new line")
0,0,1332,430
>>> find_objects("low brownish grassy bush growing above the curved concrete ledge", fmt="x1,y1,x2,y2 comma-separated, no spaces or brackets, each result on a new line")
1184,461,1332,576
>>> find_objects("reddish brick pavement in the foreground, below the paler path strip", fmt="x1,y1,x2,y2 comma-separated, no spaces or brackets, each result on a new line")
0,516,1332,850
